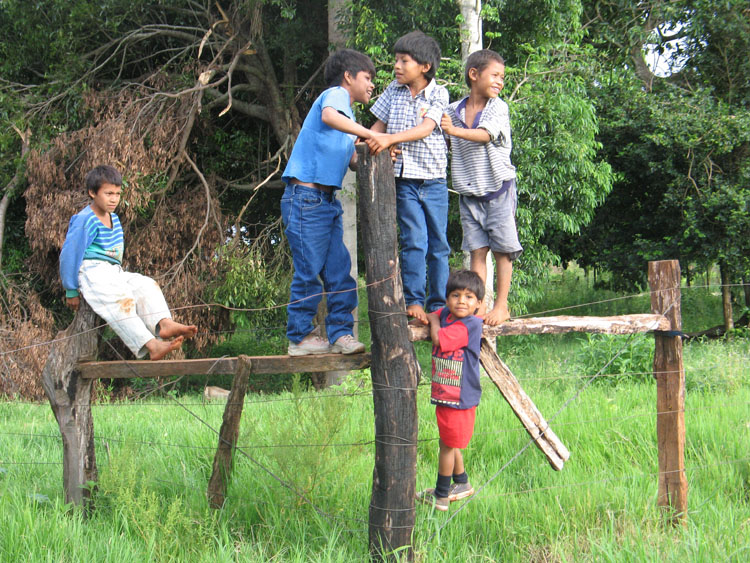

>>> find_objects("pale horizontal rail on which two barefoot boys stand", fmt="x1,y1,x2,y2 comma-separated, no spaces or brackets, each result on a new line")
409,313,670,341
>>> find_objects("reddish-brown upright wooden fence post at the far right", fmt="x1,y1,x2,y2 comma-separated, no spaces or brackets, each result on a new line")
648,260,688,524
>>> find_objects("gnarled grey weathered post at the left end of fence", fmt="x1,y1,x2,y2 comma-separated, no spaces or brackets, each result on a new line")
42,299,98,513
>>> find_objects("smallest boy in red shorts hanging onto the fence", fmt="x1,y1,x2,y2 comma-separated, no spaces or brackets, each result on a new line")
417,270,484,512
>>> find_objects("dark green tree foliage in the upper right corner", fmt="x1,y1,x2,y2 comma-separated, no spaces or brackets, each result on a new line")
557,1,750,304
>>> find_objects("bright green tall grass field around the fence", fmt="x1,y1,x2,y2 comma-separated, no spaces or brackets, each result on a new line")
0,270,750,562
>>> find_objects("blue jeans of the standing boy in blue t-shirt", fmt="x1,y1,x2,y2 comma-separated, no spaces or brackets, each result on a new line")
281,184,357,344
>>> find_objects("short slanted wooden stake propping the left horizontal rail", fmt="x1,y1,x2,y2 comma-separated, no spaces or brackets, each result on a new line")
207,356,252,508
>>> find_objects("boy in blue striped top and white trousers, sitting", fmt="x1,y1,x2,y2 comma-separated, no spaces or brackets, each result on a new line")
60,165,198,360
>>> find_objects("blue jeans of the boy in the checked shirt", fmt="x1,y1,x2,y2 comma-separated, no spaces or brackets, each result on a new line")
396,178,451,313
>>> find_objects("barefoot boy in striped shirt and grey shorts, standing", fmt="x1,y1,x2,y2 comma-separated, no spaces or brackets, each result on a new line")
440,53,523,326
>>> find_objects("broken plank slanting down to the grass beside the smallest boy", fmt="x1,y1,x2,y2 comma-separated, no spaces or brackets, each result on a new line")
479,338,570,471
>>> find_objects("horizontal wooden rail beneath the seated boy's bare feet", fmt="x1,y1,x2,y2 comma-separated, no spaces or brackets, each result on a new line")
78,354,370,379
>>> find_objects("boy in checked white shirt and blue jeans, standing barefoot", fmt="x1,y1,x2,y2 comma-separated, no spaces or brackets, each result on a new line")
365,31,450,324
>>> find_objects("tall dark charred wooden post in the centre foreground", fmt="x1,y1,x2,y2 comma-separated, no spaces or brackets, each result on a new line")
357,146,419,560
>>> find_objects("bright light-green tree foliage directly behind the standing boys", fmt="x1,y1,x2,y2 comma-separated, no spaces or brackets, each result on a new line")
348,0,613,312
